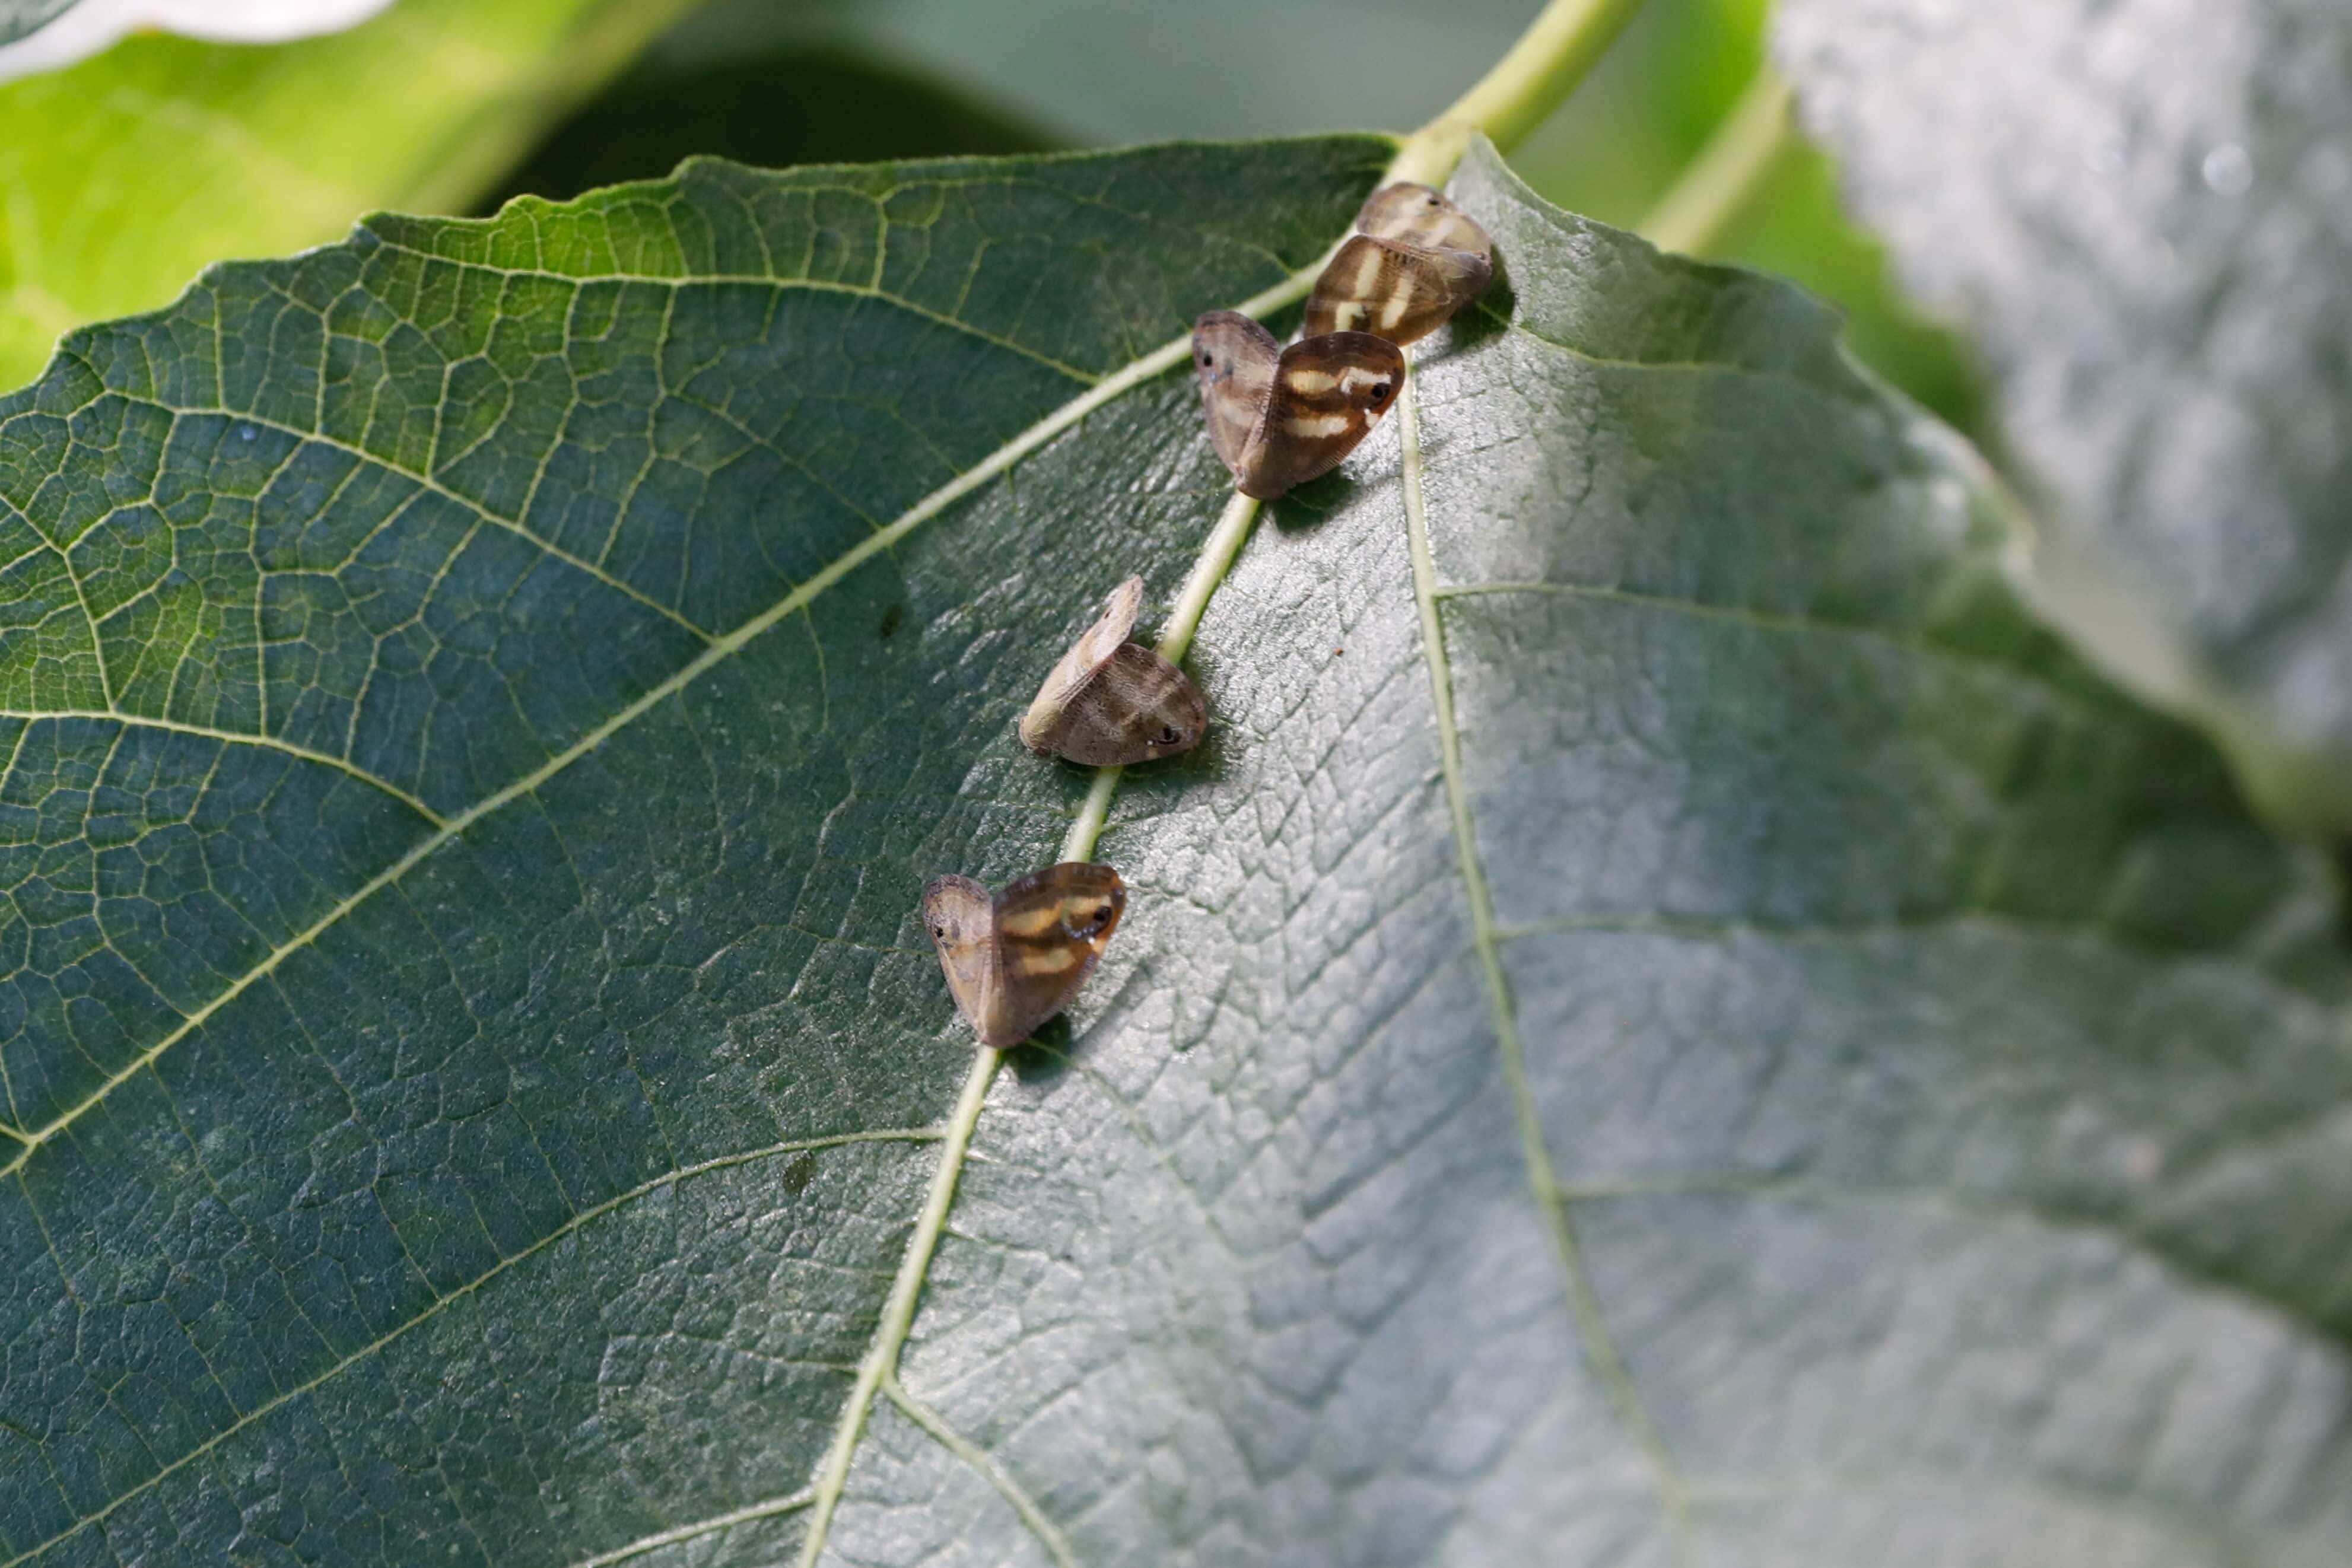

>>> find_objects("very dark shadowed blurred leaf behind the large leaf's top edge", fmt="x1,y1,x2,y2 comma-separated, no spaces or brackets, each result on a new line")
480,44,1051,212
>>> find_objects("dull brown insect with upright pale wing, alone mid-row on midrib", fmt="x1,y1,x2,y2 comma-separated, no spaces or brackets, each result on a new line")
1021,576,1209,766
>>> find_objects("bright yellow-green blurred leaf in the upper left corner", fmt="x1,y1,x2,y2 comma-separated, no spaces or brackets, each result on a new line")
0,0,685,388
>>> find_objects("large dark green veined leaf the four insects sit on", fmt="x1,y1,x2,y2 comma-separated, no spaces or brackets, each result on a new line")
0,139,2352,1568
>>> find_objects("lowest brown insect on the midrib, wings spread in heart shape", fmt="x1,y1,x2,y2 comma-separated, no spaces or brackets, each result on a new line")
922,860,1127,1051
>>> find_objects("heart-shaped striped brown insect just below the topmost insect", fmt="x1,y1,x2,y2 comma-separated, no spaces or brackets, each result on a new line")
1193,310,1404,501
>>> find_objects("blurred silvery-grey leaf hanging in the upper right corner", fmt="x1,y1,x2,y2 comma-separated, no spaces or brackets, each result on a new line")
1781,0,2352,835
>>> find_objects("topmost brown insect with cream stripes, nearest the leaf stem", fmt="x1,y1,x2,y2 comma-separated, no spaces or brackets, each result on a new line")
1305,186,1493,344
